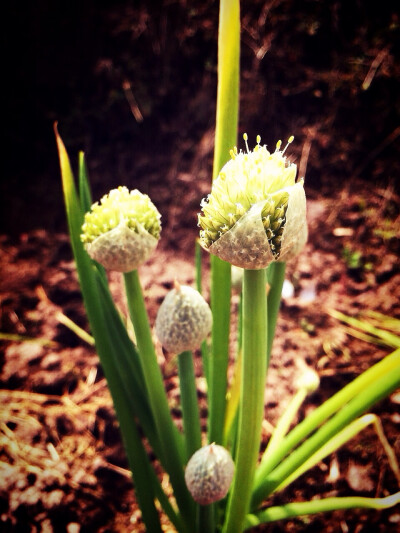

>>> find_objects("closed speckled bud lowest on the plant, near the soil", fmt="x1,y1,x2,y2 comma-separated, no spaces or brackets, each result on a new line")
185,444,235,505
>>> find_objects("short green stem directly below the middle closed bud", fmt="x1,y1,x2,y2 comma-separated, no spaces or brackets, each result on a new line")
178,352,201,460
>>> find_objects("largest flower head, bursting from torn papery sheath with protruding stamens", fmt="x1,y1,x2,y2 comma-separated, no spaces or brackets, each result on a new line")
199,135,307,269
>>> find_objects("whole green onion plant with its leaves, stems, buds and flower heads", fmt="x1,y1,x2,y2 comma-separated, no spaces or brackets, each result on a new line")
55,0,400,533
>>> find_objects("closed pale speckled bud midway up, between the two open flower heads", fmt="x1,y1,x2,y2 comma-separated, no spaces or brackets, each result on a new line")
156,282,212,353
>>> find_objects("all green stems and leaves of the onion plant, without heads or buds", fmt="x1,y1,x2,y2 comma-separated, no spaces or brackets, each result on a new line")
56,0,400,533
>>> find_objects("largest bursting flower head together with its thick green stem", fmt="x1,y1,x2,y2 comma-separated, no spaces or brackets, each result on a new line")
199,134,308,533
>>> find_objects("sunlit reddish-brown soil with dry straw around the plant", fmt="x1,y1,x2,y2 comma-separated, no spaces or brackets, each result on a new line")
0,180,400,532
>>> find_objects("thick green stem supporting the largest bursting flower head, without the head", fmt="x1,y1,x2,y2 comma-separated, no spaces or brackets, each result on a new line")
223,270,267,533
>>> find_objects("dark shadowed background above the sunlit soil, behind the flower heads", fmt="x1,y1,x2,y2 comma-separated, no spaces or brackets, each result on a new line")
0,0,400,236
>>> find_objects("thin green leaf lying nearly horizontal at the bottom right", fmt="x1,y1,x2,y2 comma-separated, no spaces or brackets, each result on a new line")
244,492,400,529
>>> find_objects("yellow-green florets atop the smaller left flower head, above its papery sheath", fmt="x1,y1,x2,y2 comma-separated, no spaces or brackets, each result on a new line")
81,186,161,243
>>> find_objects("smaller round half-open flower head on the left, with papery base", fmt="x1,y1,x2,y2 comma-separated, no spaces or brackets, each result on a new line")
81,187,161,272
